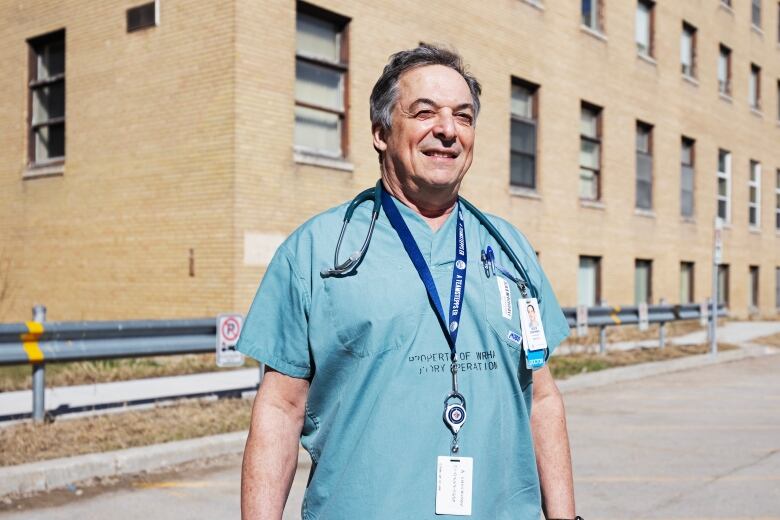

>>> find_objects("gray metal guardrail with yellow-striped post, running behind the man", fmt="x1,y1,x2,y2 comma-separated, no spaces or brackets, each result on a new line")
0,304,726,421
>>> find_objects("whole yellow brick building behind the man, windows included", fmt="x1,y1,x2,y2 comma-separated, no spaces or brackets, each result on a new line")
0,0,780,321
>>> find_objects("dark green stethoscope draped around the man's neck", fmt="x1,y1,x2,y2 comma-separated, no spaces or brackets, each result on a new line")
320,179,539,300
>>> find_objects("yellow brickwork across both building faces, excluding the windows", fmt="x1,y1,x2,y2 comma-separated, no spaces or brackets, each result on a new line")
0,0,780,321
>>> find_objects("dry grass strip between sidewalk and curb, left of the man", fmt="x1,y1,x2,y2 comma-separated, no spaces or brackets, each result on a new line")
0,399,252,466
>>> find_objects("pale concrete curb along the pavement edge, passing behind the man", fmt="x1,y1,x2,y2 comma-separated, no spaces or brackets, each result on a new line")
0,344,780,498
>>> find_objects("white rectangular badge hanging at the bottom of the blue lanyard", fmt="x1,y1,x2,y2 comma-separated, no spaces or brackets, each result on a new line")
436,456,474,516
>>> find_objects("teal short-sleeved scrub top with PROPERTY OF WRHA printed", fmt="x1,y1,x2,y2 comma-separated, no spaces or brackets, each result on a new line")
238,194,569,520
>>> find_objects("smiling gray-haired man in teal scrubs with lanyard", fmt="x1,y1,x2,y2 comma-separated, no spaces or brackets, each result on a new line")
238,45,575,520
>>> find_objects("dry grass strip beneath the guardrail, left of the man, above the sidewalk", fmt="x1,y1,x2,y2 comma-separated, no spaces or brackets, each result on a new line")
0,354,258,392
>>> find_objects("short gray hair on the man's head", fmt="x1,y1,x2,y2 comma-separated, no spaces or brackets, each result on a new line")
370,43,482,130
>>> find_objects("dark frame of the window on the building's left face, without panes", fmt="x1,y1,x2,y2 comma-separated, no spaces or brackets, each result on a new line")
26,28,67,169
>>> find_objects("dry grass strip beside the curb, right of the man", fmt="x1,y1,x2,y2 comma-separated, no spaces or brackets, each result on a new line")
549,343,737,379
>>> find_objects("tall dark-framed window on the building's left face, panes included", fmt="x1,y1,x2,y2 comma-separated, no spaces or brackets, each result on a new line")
28,30,65,166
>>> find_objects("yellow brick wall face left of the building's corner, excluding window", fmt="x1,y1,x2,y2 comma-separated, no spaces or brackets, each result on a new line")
0,0,235,321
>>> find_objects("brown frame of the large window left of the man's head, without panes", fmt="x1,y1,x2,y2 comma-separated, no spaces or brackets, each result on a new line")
293,0,350,160
